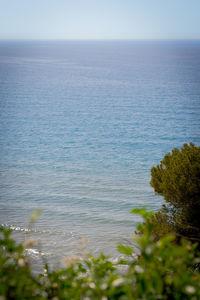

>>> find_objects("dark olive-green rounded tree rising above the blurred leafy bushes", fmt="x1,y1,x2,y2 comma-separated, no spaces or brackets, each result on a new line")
151,143,200,241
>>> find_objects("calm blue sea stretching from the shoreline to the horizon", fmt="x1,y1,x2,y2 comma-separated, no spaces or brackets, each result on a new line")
0,41,200,265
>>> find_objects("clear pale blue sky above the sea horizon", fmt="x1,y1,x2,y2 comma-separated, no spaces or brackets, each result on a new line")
0,0,200,39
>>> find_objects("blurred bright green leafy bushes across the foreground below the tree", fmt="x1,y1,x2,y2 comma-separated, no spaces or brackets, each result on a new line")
0,209,200,300
